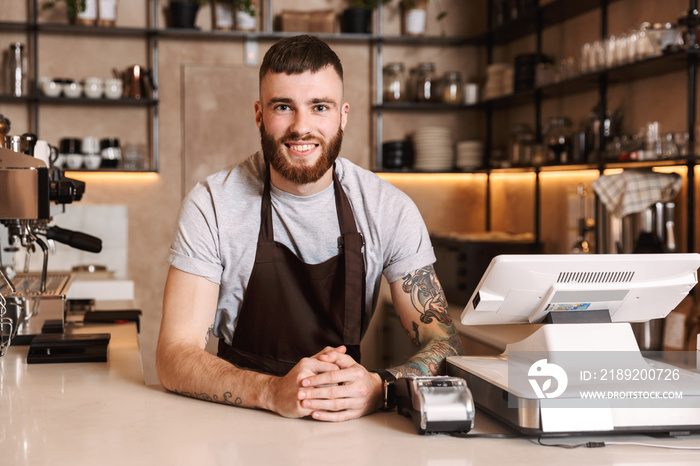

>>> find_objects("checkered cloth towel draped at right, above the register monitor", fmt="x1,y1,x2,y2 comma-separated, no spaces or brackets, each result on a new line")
593,169,683,218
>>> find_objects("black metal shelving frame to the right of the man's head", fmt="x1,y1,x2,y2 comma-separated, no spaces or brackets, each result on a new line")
372,0,700,255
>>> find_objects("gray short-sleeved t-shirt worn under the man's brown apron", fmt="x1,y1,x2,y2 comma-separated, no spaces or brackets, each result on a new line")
169,152,435,344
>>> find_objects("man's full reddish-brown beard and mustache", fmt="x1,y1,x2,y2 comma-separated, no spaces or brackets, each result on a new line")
260,125,343,184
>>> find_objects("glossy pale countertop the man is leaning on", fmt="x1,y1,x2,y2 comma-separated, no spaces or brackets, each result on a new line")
0,324,700,466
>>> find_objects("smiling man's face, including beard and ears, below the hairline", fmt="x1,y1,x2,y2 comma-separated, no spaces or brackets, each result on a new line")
255,66,349,184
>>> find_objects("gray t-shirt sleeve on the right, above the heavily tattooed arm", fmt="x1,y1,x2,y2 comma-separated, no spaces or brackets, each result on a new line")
382,188,435,283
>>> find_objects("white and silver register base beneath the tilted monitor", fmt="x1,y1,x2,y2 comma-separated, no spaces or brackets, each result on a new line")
447,323,700,435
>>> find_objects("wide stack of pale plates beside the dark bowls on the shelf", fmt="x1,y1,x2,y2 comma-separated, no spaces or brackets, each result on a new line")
413,126,454,171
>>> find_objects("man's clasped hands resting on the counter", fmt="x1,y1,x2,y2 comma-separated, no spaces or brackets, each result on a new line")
273,346,382,422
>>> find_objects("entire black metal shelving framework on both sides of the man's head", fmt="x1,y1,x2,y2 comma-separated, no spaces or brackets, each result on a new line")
6,0,699,244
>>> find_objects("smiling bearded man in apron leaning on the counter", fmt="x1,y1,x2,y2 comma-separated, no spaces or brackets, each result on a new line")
156,35,462,421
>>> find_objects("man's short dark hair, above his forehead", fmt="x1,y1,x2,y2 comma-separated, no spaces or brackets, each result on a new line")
260,34,343,82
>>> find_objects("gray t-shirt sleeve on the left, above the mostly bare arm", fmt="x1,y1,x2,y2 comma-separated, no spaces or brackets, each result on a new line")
168,184,223,285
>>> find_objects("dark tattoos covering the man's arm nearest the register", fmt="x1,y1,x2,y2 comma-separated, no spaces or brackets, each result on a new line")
391,265,463,377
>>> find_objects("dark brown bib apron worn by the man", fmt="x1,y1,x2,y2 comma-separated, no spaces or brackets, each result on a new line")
218,167,370,376
